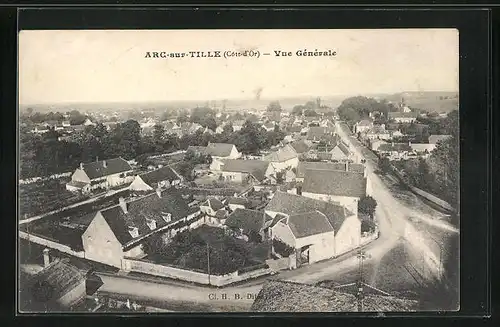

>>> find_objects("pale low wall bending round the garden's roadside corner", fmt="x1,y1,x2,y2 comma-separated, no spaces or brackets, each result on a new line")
122,258,272,287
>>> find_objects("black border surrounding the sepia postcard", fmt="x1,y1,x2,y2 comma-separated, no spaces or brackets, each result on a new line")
1,7,492,323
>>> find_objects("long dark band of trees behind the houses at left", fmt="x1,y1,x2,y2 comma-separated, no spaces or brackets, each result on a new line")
20,120,285,179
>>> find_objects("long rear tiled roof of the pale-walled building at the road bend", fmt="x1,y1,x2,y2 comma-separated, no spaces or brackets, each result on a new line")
265,191,353,233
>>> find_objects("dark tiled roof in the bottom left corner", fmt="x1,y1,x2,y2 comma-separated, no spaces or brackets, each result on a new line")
21,259,85,302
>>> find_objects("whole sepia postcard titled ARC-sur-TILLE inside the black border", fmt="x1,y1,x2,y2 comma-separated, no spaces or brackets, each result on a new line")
17,28,460,314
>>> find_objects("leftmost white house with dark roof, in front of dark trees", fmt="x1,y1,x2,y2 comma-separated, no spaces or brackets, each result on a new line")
66,157,134,192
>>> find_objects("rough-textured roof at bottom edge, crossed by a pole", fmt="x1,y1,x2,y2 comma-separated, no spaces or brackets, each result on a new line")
251,280,418,312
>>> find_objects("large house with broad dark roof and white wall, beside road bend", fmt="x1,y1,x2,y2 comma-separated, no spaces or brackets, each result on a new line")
301,170,371,213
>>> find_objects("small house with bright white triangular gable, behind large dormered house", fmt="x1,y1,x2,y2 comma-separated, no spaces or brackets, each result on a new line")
129,166,183,191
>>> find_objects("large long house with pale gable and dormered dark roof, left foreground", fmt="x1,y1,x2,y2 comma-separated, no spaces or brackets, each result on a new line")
81,189,201,268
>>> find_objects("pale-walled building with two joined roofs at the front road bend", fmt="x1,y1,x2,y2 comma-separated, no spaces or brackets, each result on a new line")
264,191,361,263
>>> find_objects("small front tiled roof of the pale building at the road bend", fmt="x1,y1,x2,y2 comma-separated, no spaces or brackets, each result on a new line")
287,210,334,238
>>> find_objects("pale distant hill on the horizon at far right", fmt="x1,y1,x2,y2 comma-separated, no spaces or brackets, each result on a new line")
374,92,458,113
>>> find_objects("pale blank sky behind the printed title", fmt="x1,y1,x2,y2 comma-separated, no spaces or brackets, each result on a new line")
19,29,459,105
